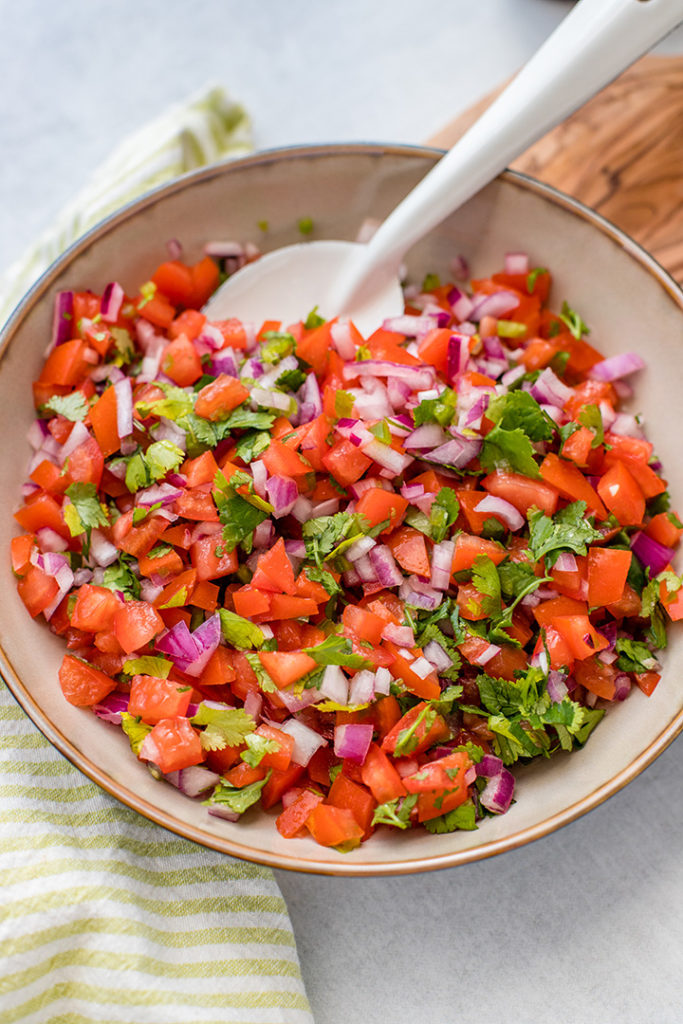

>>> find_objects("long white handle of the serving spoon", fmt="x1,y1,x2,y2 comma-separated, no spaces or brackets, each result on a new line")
336,0,683,311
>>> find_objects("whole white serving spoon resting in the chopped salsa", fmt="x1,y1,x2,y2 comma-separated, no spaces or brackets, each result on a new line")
205,0,683,333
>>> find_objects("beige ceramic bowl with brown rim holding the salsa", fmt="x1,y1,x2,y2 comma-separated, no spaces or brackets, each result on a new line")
0,144,683,876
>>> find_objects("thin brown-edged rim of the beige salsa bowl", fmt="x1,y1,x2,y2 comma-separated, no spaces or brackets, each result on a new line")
0,142,683,878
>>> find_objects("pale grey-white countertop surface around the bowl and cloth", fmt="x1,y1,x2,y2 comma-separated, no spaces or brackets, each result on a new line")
0,0,683,1024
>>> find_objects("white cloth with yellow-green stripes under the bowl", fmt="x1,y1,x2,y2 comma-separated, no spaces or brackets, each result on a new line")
0,89,312,1024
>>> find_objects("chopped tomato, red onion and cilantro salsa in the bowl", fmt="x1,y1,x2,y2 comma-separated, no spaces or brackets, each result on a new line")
11,244,683,851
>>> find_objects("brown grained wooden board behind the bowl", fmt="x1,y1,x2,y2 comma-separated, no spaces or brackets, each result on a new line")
430,56,683,284
